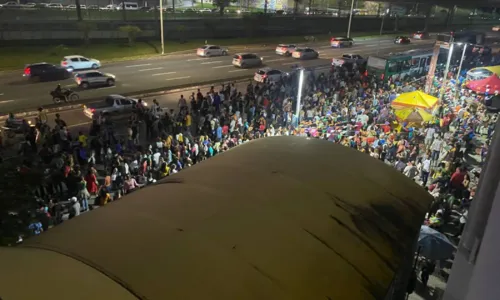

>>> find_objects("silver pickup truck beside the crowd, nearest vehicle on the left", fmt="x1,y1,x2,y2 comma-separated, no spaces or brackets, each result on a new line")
83,95,147,119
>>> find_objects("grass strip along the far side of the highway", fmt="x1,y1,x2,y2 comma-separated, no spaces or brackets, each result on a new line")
0,32,390,71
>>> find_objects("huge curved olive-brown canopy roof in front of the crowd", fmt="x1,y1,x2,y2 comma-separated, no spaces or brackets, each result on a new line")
0,137,432,300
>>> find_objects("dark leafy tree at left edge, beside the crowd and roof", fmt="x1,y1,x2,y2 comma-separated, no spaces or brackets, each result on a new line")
0,159,44,245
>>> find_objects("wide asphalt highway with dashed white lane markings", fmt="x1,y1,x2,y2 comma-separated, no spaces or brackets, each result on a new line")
0,37,434,115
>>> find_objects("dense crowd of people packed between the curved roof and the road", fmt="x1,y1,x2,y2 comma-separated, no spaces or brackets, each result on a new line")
0,49,496,260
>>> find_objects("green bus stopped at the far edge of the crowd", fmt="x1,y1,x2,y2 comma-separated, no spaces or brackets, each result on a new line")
366,49,433,81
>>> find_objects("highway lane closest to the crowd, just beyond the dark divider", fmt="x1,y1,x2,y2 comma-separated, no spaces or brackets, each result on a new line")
0,43,434,114
